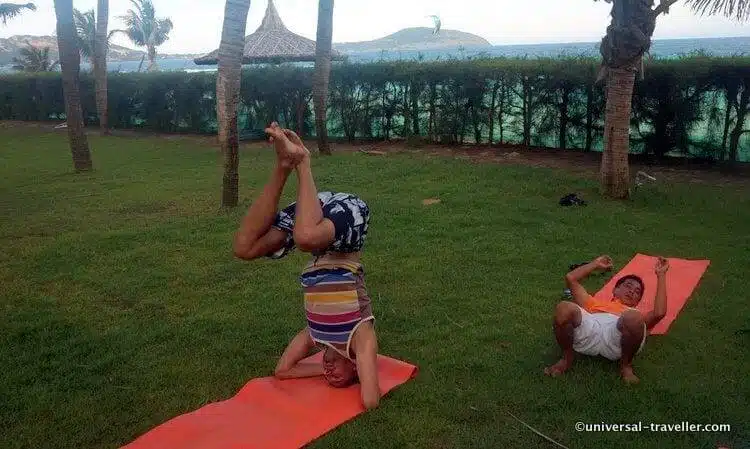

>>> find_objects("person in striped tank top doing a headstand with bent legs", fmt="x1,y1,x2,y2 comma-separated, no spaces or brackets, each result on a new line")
234,123,380,409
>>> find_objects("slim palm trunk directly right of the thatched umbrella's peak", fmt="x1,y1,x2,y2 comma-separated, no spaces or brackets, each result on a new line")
313,0,333,154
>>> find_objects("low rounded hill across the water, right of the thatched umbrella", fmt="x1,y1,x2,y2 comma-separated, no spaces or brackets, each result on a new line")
333,28,491,53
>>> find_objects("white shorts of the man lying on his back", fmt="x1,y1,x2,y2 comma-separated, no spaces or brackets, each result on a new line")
573,306,646,360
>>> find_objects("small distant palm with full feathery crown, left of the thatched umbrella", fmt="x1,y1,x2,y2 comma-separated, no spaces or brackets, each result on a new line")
116,0,174,70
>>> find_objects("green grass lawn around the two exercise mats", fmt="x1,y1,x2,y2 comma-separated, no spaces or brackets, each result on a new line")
0,130,750,449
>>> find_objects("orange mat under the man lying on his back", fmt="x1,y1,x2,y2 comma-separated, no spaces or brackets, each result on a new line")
594,254,711,335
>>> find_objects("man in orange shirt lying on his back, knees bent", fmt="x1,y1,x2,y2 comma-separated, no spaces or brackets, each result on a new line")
544,256,669,383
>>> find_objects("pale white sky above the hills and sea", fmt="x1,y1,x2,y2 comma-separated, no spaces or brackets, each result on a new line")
0,0,750,54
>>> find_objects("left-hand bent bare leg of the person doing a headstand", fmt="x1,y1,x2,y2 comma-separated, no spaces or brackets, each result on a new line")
234,165,291,260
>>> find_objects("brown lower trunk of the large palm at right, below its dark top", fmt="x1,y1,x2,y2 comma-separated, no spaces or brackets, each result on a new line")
601,67,635,199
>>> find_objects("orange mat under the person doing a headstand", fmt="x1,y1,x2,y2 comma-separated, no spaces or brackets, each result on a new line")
124,353,417,449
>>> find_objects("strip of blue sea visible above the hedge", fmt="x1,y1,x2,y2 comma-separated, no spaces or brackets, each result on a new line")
42,36,750,72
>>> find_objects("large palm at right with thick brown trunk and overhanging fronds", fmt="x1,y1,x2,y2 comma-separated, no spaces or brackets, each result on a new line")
595,0,750,199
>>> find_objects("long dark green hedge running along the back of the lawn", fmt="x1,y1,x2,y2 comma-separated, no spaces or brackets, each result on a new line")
0,55,750,160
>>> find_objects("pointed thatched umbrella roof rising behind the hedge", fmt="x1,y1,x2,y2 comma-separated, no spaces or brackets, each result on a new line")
193,0,344,65
